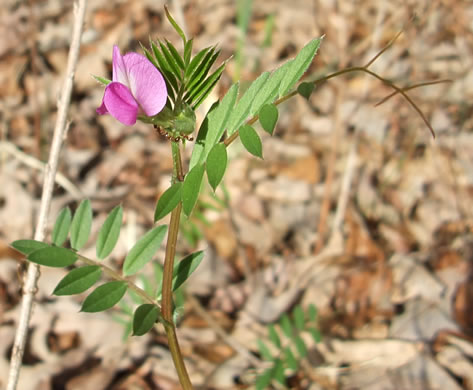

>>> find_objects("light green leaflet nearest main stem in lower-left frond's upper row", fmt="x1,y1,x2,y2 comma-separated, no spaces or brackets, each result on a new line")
123,225,167,276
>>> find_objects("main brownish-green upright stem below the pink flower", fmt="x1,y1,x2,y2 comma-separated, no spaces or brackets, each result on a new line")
161,142,193,390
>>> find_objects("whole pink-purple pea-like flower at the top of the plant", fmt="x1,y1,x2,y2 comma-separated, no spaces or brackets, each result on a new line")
96,46,167,126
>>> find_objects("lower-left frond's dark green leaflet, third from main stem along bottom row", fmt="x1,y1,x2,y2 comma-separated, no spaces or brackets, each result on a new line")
53,265,102,295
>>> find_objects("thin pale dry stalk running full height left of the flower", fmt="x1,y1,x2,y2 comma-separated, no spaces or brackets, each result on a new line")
6,0,87,390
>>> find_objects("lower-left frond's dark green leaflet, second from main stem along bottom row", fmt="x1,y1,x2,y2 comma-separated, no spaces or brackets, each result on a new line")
80,281,128,313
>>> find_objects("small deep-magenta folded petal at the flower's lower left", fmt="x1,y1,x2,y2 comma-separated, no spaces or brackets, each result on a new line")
97,82,138,126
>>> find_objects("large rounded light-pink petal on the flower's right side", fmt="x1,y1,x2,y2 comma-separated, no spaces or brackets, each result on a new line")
122,53,167,116
